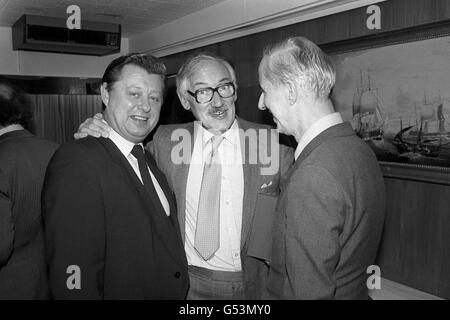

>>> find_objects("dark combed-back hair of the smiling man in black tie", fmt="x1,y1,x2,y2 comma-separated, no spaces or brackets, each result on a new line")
102,53,166,91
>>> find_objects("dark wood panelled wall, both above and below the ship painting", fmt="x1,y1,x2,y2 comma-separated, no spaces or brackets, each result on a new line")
161,0,450,299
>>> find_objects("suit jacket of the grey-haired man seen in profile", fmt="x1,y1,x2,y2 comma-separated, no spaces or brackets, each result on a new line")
267,123,385,299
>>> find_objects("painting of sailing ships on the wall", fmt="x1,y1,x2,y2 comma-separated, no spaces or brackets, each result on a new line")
332,37,450,167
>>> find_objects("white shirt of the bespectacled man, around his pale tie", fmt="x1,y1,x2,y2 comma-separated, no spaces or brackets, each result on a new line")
185,120,244,271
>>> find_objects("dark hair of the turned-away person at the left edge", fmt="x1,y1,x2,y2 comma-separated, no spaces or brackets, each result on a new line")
0,79,33,128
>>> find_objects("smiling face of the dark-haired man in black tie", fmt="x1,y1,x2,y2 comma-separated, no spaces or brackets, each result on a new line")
101,64,164,143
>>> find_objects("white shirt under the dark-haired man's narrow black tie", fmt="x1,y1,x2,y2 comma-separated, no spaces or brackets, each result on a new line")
109,128,170,216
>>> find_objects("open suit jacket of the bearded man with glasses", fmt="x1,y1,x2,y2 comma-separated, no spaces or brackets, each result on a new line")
147,118,294,299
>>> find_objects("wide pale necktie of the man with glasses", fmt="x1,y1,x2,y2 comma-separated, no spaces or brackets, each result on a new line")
194,136,227,260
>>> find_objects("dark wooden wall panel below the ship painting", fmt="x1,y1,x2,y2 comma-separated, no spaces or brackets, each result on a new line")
377,178,450,299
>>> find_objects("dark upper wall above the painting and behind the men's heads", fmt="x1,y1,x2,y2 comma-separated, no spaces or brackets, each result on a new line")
162,0,450,123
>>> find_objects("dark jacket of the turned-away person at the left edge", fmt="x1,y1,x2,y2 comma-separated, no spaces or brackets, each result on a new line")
0,130,58,299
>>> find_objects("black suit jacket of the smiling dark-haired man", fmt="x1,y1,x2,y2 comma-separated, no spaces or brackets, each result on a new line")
43,137,188,299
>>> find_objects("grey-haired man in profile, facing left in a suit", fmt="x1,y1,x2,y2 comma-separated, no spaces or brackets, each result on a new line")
259,37,385,299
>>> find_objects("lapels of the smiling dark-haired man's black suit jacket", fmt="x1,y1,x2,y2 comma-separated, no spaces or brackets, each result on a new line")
98,138,184,265
